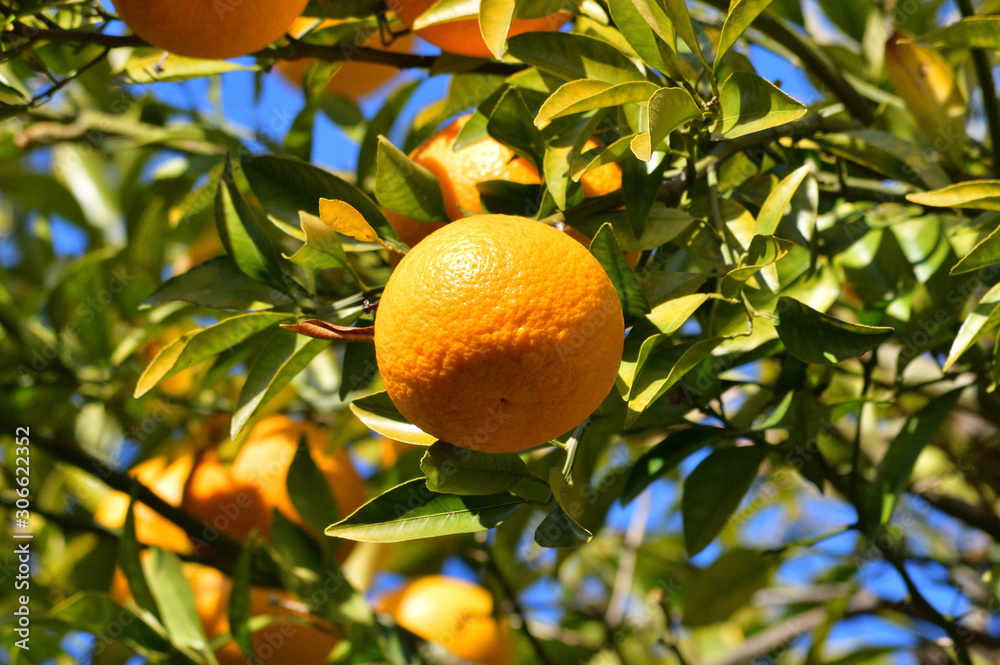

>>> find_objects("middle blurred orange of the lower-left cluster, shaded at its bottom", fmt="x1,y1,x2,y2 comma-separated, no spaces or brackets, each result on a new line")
181,451,271,544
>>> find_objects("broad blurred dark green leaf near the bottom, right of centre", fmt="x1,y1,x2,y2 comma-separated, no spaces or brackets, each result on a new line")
683,549,781,628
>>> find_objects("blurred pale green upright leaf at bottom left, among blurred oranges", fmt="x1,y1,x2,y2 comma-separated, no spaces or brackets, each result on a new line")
142,547,211,653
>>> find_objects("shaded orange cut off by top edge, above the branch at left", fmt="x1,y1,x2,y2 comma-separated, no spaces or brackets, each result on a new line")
112,0,308,60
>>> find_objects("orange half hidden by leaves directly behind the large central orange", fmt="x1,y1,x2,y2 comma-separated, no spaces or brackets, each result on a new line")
385,115,622,247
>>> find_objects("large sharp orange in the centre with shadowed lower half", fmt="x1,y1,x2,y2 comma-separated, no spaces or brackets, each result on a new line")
375,215,625,452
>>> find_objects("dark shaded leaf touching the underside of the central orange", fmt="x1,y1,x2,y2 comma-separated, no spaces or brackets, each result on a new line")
420,441,542,495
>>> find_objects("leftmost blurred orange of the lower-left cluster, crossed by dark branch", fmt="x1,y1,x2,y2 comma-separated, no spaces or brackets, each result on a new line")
94,455,194,554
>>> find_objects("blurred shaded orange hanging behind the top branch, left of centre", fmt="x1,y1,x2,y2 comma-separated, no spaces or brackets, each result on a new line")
277,18,413,99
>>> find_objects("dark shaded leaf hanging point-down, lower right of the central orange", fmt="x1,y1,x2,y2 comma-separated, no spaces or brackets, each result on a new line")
681,446,766,556
